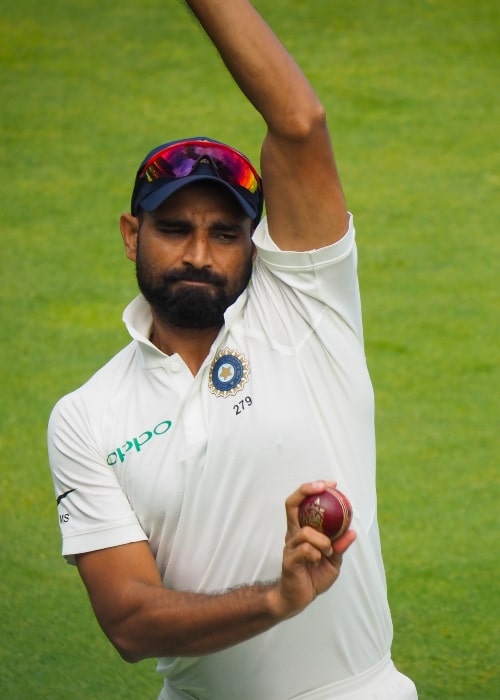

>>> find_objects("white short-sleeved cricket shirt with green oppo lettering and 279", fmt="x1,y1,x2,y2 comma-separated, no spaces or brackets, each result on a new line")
49,220,414,700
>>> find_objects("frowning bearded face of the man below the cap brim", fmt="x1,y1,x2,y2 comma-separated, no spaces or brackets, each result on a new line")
136,182,253,328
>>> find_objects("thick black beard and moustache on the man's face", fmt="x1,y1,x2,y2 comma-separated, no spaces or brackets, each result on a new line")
136,255,252,329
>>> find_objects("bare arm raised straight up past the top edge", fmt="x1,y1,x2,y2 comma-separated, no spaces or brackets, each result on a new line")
186,0,348,250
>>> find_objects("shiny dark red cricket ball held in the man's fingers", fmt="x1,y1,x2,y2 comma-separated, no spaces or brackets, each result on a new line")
299,489,352,542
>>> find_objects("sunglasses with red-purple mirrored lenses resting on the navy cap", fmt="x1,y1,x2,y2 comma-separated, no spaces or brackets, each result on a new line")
138,140,262,194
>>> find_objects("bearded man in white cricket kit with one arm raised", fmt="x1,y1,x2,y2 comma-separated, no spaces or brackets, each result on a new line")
49,0,416,700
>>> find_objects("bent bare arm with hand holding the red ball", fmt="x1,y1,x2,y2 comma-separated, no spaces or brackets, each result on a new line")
76,482,355,662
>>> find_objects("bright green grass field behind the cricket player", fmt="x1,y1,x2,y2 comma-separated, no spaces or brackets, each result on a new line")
0,0,500,700
